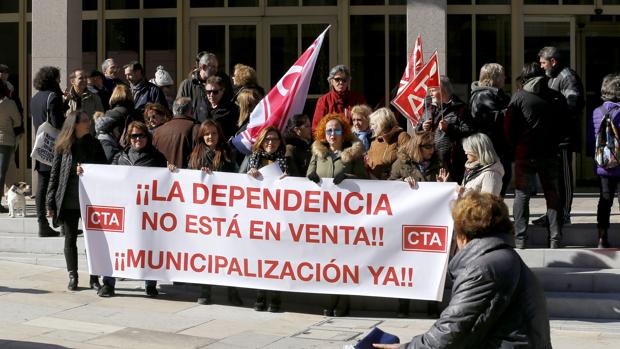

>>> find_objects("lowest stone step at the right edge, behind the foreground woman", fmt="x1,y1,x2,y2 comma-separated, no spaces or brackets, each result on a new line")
545,292,620,320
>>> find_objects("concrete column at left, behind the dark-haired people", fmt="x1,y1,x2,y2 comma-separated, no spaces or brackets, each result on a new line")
32,0,82,93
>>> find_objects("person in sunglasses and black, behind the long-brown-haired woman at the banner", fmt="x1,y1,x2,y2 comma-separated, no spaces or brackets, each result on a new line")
197,76,239,140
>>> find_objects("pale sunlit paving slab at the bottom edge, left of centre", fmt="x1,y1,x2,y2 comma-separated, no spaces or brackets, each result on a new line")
88,328,215,349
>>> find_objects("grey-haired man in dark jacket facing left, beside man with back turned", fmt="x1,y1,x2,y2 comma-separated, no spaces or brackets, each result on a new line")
533,46,584,225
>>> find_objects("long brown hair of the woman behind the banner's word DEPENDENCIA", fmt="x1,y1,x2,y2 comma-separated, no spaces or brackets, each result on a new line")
189,120,230,171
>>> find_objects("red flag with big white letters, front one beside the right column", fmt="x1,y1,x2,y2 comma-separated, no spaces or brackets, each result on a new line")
392,51,439,126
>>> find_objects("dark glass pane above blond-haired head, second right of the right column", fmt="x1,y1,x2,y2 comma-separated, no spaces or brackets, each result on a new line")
474,15,512,91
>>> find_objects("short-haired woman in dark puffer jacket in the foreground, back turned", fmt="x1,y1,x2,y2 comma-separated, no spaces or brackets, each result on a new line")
374,191,551,349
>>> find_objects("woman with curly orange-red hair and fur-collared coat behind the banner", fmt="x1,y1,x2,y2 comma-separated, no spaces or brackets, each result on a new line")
307,113,367,316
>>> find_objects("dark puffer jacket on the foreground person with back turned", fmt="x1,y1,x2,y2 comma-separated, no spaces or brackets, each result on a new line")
401,233,551,349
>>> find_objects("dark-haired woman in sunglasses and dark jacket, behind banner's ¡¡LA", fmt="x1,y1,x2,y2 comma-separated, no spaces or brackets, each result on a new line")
97,121,167,297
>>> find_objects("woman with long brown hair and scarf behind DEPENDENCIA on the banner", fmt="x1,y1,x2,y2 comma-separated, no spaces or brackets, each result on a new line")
189,120,243,306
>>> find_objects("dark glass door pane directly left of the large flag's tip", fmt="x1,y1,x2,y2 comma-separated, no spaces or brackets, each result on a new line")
268,24,299,86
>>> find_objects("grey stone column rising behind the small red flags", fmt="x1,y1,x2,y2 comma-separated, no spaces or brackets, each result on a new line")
407,0,448,75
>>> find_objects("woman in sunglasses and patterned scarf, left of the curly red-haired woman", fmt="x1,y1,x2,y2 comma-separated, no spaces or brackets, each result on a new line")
248,126,289,313
